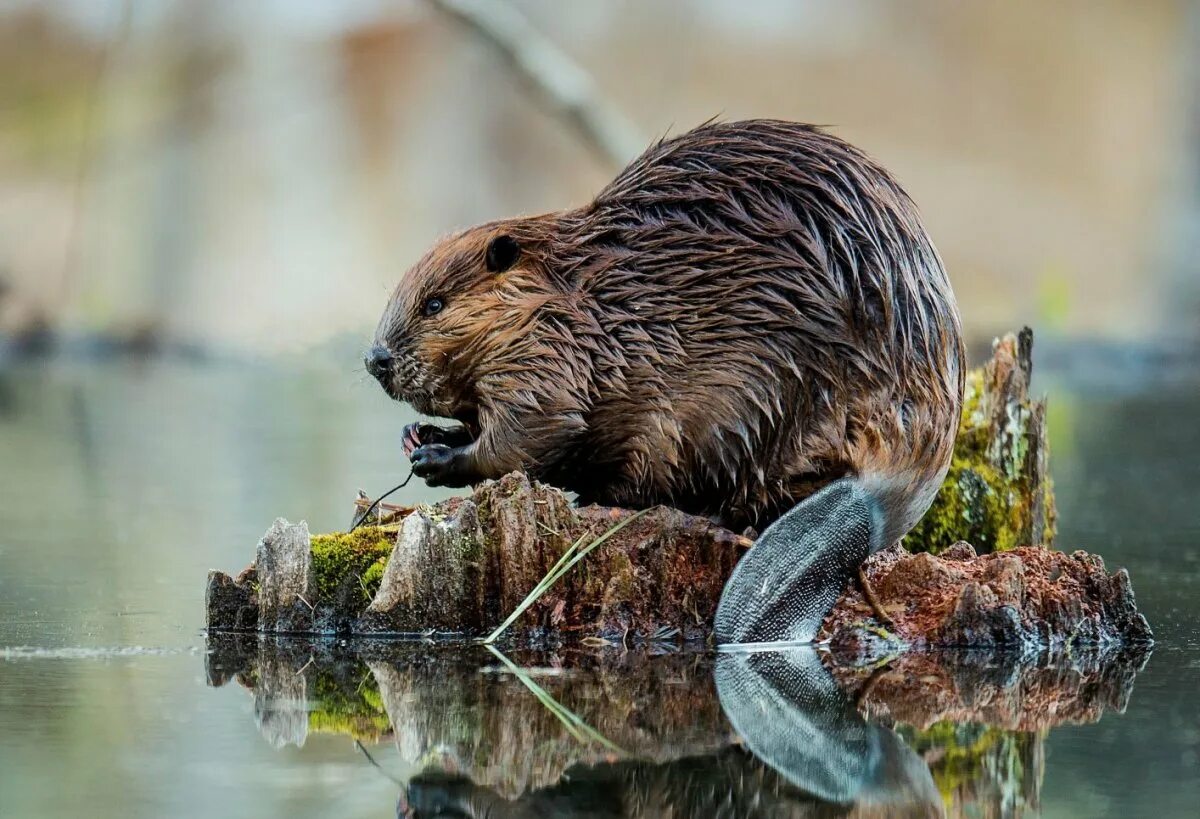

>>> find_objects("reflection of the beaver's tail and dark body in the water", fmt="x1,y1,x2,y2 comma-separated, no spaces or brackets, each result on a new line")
397,648,943,819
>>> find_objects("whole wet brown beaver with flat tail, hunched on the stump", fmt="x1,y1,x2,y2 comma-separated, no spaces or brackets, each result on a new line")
365,120,965,642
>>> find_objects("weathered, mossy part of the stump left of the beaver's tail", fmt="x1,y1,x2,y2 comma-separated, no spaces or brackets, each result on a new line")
208,472,750,640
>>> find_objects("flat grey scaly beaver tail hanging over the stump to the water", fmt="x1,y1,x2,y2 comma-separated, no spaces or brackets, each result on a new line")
714,478,902,644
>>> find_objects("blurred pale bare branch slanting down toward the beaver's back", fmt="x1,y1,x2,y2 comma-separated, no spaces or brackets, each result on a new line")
426,0,646,168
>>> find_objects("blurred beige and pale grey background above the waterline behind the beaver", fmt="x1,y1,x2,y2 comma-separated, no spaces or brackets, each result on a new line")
0,0,1200,354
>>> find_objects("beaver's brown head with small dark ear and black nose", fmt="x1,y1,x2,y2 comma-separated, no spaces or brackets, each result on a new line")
365,217,551,426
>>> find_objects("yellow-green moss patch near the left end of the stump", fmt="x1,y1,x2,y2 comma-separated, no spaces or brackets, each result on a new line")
312,526,396,602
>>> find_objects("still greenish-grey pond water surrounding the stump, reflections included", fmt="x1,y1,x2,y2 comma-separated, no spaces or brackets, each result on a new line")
0,355,1200,819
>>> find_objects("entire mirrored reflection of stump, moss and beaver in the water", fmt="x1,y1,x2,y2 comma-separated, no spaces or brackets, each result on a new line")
208,635,1144,819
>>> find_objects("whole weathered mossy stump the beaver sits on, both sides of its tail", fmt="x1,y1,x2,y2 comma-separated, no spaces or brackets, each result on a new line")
206,330,1150,650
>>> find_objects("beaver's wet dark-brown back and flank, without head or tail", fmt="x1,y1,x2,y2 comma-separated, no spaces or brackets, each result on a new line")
547,120,962,525
